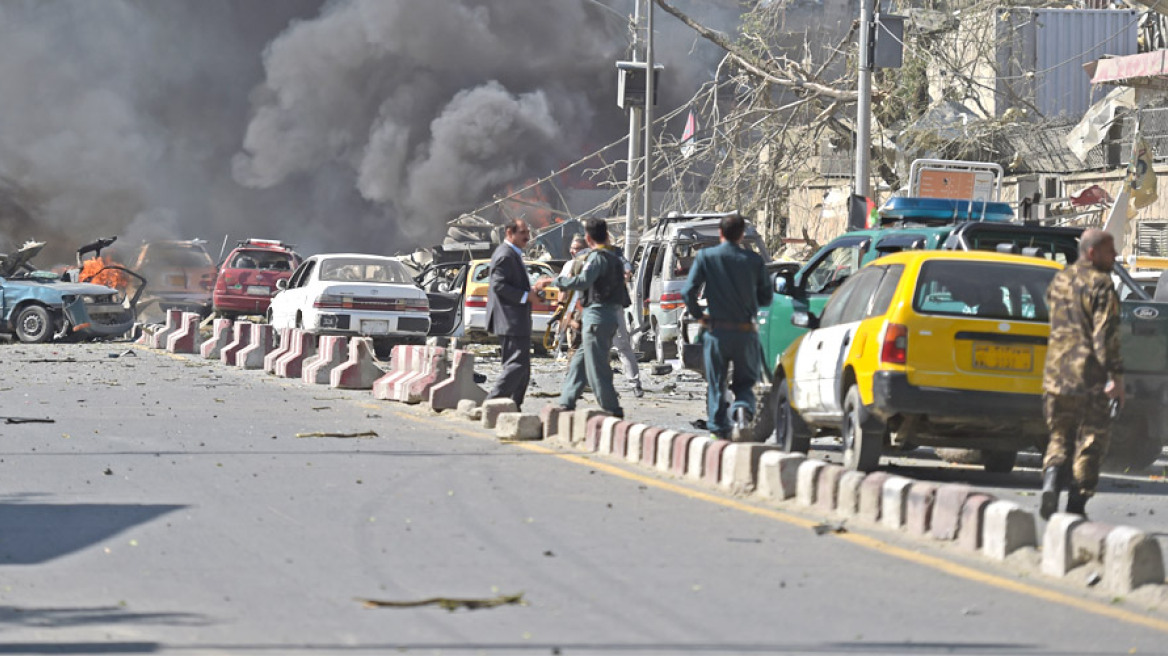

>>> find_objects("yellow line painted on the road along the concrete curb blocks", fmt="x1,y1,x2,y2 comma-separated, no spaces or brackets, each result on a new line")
385,403,1168,633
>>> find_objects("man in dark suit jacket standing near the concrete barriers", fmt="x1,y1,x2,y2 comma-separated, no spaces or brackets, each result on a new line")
487,218,548,407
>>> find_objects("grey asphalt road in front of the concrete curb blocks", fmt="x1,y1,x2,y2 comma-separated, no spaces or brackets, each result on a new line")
0,344,1168,655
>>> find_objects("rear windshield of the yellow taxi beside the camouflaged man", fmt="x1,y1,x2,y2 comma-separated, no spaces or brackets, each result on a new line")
912,260,1057,321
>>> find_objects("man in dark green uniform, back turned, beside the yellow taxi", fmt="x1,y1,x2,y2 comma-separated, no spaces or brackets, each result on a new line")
682,214,773,441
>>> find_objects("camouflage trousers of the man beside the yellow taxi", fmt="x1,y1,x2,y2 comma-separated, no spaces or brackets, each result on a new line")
1042,390,1111,496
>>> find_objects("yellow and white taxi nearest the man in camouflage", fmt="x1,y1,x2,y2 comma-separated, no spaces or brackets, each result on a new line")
774,251,1063,472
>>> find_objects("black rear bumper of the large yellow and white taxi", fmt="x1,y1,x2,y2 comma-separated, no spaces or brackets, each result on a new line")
870,371,1042,425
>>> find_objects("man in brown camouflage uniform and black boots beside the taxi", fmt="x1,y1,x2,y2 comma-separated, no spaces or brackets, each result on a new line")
1040,229,1124,518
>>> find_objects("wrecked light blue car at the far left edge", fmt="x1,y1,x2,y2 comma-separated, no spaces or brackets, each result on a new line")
0,242,134,343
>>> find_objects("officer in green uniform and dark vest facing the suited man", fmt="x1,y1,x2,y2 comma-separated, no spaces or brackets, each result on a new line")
554,218,631,417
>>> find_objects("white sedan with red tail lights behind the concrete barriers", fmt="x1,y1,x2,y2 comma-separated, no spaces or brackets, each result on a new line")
267,253,430,351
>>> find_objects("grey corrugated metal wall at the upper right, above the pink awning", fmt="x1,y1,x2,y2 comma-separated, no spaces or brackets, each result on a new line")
995,8,1139,119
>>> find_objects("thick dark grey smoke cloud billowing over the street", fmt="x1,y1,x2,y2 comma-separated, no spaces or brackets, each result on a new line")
0,0,734,260
